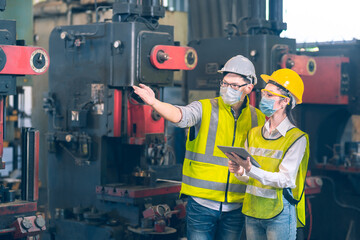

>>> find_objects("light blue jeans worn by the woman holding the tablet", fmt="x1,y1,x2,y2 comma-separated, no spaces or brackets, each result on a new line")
245,198,296,240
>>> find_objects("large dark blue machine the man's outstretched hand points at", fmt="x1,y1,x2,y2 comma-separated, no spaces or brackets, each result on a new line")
44,1,197,239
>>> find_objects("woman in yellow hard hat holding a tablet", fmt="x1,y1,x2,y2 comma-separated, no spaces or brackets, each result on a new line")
227,69,309,240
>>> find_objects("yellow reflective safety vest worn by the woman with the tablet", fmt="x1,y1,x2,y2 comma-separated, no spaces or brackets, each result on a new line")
242,127,309,227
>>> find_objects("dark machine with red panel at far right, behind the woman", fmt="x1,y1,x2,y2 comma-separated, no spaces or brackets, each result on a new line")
298,40,360,239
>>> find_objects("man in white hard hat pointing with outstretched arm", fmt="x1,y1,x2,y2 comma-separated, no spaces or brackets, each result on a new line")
134,55,265,240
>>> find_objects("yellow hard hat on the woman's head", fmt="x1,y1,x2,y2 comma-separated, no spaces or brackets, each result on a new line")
260,68,304,104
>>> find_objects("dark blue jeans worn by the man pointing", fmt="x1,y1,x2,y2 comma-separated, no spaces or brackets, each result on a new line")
186,197,245,240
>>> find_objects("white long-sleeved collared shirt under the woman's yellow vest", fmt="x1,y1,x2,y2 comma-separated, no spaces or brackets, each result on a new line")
239,118,307,188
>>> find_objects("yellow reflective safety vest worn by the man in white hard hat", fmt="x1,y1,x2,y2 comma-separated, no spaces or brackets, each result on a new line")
180,97,265,202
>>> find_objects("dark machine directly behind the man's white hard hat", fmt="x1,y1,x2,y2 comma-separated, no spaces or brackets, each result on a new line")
185,0,296,105
